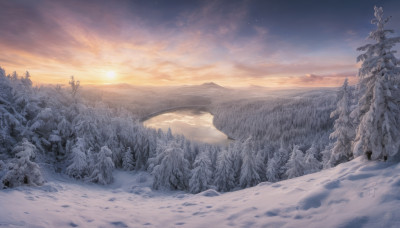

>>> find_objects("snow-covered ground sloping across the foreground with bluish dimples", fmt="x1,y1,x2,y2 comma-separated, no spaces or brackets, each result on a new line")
0,158,400,228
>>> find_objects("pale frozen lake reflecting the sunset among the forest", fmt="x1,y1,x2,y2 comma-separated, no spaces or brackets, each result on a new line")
143,110,231,144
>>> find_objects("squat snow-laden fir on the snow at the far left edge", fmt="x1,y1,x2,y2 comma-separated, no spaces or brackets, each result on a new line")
1,139,44,188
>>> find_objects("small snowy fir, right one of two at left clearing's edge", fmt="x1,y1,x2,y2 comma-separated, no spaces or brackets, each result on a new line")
90,146,114,185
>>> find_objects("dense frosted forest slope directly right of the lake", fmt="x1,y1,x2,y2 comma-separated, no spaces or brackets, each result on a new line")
213,93,336,149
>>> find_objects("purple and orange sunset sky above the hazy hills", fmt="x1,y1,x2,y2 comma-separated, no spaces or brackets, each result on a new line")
0,0,400,87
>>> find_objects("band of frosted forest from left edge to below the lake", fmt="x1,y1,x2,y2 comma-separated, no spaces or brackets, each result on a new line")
0,69,336,193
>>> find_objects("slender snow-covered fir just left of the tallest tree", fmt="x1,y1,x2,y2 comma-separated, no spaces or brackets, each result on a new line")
330,78,355,165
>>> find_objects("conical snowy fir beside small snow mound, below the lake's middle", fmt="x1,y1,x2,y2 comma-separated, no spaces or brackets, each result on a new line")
189,153,212,193
